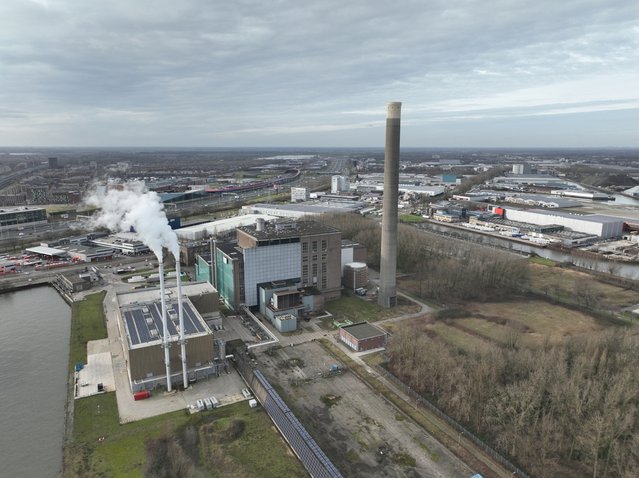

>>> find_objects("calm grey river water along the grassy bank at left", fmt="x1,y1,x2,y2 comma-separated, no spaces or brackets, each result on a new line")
0,286,71,478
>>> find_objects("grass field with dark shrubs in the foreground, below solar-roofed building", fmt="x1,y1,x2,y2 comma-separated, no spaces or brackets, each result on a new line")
63,393,306,478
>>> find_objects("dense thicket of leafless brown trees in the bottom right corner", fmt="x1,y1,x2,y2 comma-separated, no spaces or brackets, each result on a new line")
387,328,639,478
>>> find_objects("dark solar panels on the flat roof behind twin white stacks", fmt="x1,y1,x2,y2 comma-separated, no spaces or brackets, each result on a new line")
122,301,206,346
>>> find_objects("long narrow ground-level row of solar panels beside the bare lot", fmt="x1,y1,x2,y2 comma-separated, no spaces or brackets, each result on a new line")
253,370,342,478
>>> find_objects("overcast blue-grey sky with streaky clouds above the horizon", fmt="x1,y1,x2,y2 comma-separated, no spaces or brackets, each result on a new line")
0,0,639,147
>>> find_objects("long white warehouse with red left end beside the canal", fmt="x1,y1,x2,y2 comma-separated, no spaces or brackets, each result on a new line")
504,208,624,239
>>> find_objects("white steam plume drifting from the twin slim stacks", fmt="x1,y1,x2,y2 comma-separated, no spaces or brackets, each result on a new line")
86,182,180,261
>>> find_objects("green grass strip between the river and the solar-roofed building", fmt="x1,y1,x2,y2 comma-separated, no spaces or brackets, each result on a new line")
69,291,107,371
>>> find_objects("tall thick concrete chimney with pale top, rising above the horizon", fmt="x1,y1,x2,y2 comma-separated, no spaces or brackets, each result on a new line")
377,102,402,308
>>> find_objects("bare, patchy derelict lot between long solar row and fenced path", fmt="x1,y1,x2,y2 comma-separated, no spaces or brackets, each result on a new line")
257,342,472,478
